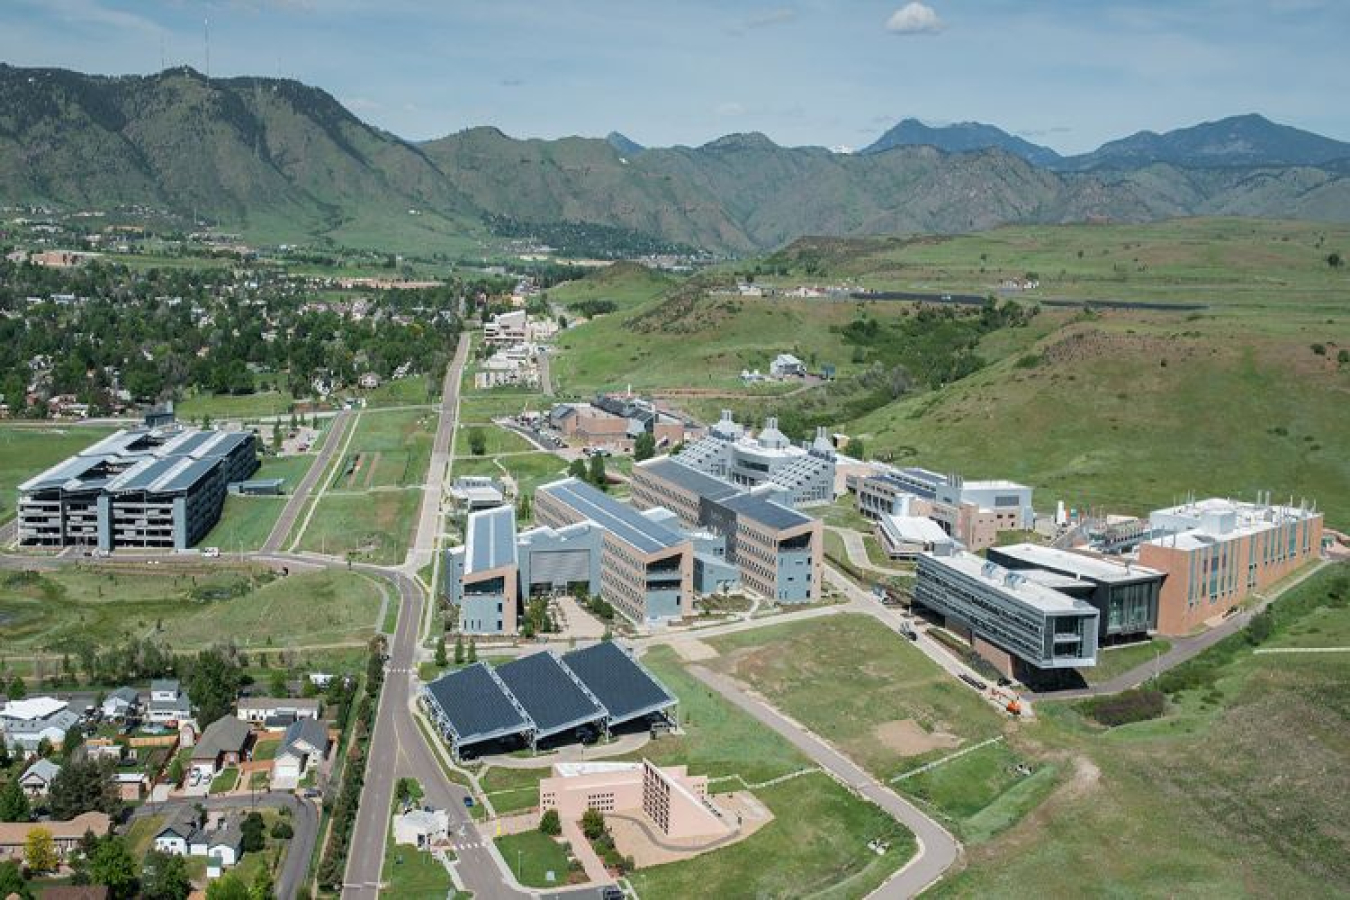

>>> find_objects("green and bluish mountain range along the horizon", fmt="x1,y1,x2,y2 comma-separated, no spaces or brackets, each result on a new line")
0,65,1350,254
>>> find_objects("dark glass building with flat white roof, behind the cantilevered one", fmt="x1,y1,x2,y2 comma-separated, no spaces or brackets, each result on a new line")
986,544,1165,645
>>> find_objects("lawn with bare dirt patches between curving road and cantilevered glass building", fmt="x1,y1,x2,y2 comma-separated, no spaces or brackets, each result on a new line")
709,614,1004,780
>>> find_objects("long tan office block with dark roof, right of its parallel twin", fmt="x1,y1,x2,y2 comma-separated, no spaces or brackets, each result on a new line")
632,453,824,603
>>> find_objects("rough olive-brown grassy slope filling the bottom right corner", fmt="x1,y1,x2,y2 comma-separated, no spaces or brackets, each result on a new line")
934,567,1350,897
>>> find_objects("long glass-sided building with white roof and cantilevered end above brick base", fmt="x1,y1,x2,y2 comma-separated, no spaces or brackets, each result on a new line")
914,552,1100,675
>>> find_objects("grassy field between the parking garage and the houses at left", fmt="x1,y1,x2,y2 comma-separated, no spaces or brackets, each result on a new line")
0,564,381,653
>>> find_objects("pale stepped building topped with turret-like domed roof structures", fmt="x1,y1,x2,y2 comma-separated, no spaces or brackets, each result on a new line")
679,410,836,506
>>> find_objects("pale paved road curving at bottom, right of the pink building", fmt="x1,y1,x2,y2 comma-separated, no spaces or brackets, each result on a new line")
689,665,961,899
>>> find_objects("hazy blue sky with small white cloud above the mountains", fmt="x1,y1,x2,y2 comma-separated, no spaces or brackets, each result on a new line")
0,0,1350,152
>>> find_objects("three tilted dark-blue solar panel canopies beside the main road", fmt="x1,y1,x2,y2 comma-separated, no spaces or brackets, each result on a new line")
427,641,676,746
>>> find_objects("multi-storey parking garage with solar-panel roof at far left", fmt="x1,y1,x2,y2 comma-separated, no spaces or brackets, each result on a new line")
19,425,258,551
